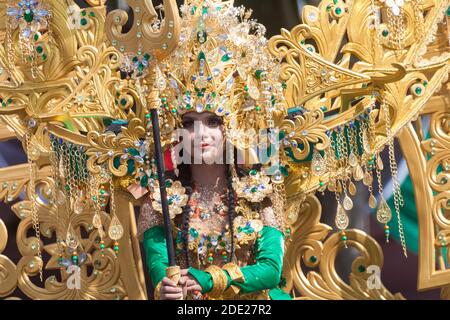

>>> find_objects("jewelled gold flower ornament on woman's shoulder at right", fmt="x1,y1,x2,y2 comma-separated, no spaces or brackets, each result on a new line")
233,170,273,202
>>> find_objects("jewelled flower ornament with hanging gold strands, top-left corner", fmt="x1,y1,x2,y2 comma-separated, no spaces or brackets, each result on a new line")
6,0,51,78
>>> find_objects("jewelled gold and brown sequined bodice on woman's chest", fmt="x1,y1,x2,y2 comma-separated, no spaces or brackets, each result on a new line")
138,192,279,269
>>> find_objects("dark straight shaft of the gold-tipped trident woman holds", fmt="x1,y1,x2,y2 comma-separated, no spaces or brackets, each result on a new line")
150,109,176,267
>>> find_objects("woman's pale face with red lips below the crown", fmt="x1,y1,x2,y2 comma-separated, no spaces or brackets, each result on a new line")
182,112,224,164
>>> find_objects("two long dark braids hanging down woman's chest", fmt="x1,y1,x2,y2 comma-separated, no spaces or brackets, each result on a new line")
178,164,236,268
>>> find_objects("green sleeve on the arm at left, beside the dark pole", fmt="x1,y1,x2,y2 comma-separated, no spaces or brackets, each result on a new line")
143,226,169,287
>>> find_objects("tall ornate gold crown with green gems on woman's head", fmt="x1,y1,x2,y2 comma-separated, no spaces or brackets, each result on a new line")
148,0,285,145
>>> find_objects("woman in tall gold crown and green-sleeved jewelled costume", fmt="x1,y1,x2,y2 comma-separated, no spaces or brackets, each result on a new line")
138,0,290,300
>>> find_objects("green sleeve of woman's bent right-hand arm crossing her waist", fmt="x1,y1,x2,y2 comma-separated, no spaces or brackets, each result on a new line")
189,226,284,293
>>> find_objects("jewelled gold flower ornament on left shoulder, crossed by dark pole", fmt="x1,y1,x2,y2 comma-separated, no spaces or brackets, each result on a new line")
152,179,188,219
